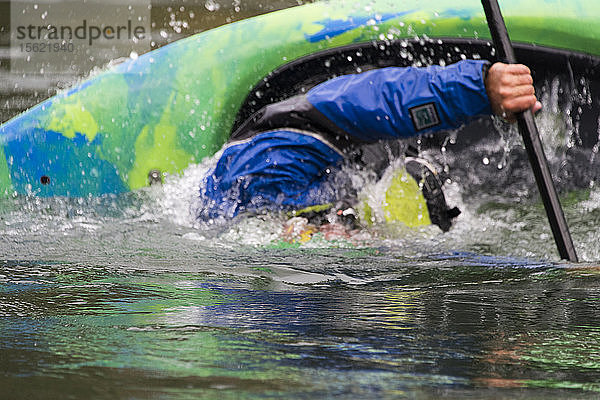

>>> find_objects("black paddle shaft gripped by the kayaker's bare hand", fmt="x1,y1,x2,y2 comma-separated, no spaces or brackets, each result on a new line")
481,0,577,262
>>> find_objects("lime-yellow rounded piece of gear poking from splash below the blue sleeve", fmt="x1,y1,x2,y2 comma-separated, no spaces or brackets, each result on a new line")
383,169,431,227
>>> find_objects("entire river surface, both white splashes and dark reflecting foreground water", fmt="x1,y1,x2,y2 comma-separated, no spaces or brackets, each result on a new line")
0,1,600,399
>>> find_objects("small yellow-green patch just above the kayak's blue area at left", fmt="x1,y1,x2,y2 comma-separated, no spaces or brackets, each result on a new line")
48,100,98,142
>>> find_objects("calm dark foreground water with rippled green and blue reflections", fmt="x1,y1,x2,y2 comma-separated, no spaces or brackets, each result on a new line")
0,256,600,398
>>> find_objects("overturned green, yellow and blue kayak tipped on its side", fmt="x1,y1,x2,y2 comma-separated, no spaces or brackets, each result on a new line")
0,0,600,197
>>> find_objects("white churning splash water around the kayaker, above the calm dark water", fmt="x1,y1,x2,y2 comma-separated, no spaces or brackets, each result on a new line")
0,74,600,264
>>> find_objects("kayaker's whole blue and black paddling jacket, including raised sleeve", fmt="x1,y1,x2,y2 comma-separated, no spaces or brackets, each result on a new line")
199,60,492,219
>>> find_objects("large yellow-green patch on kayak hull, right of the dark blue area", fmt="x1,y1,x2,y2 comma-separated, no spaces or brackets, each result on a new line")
127,94,194,189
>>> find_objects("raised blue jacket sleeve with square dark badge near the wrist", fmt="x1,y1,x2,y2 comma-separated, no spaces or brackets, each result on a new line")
307,60,492,142
